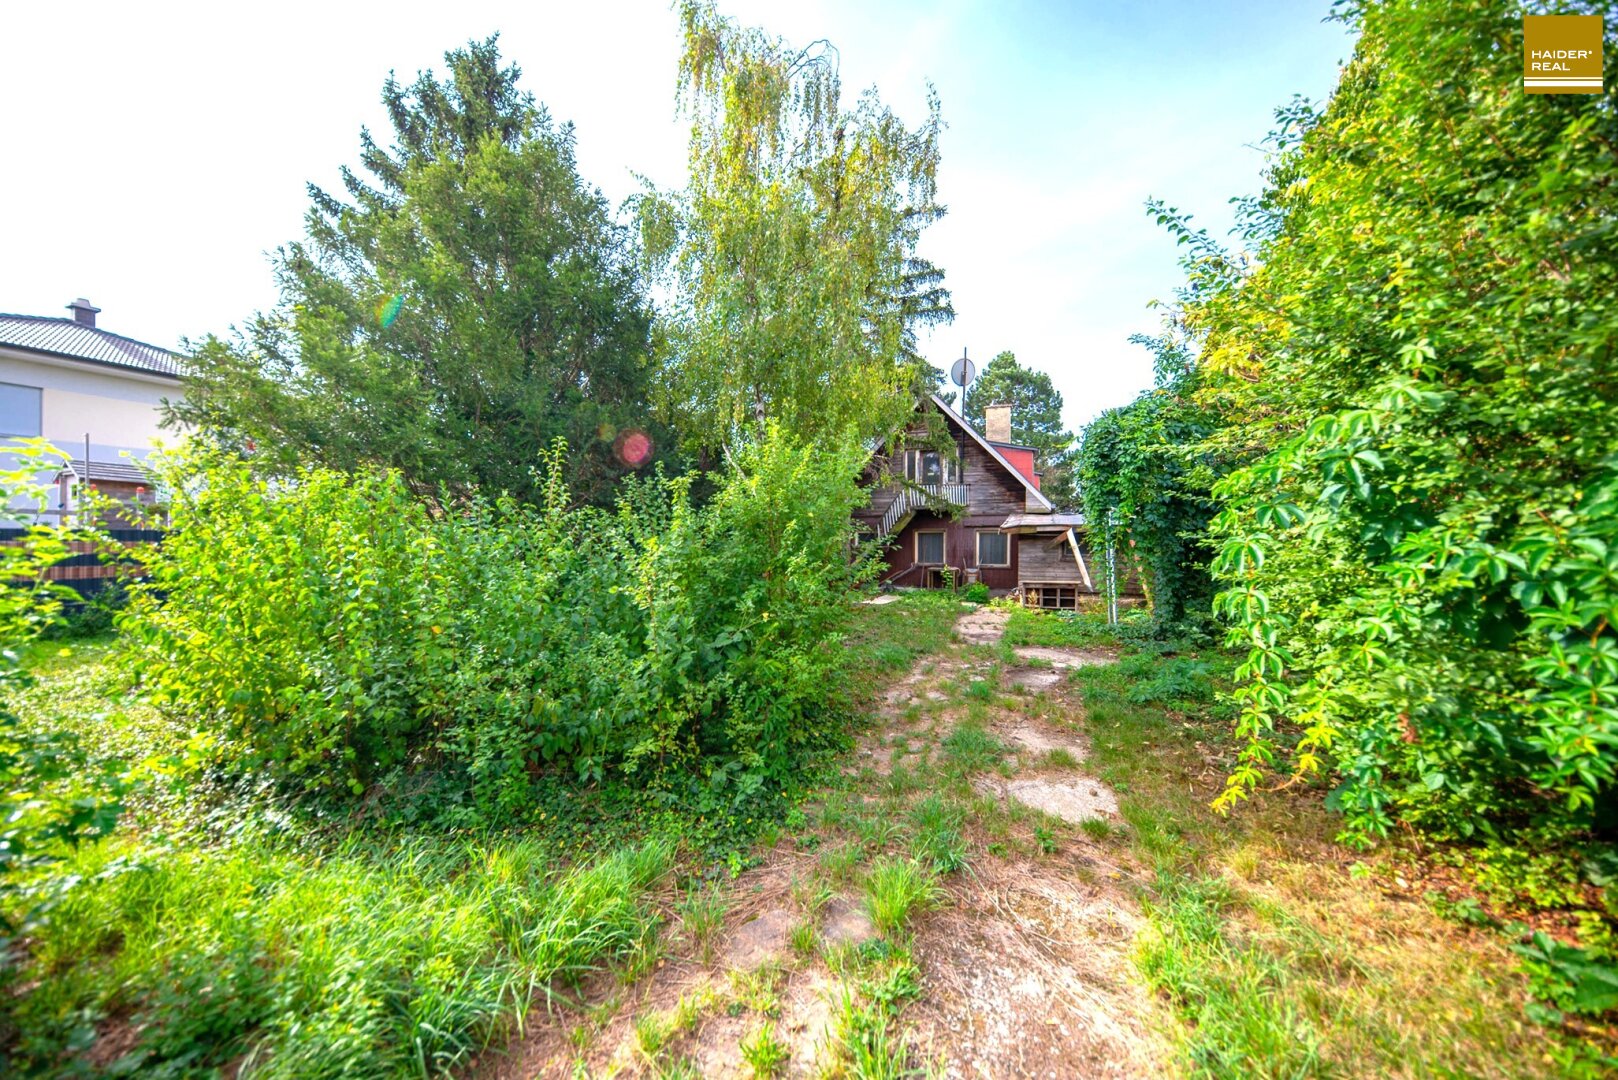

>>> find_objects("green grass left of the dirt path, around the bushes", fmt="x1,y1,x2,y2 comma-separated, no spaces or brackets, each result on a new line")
0,592,953,1077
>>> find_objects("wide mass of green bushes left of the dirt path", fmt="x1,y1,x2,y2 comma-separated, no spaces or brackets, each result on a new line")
120,434,864,821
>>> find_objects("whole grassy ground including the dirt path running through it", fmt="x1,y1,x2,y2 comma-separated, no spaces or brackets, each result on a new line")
0,594,1600,1077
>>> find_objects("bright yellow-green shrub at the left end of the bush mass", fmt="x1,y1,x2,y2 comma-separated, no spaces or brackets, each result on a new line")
120,453,443,803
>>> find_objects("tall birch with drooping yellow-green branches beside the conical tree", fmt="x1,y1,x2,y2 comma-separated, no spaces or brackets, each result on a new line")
637,0,953,450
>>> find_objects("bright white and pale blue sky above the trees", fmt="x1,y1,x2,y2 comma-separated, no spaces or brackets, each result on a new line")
0,0,1351,426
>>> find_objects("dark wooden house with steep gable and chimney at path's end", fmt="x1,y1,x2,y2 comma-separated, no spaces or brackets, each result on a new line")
854,395,1097,607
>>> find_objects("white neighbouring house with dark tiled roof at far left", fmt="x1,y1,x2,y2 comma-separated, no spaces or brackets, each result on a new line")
0,298,181,521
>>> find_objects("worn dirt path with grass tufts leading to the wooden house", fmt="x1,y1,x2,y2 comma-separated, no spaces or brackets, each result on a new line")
474,609,1160,1078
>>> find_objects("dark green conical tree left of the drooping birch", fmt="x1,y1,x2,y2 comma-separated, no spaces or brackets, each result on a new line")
172,39,662,502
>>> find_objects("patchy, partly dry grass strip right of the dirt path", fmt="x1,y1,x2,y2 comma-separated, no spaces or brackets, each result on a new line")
1074,641,1579,1077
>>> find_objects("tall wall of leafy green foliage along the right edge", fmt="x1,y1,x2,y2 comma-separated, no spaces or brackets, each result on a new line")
1163,0,1618,867
